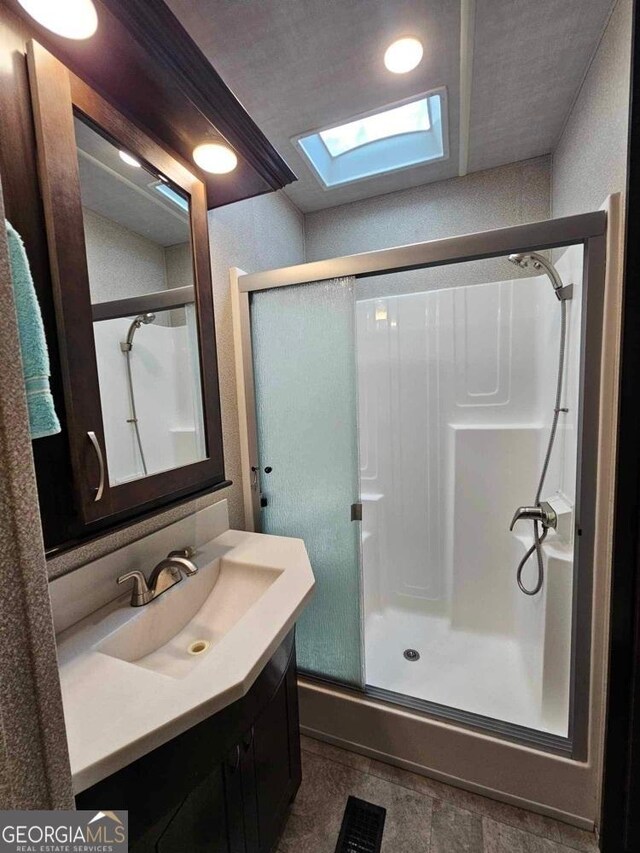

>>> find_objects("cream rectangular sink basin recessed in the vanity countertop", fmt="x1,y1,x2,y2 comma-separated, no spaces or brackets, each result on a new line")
97,558,282,678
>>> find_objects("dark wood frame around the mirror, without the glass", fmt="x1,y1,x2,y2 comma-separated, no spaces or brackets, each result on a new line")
28,42,224,523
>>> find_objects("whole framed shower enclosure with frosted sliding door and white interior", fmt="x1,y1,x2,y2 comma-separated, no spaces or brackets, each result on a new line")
235,213,606,760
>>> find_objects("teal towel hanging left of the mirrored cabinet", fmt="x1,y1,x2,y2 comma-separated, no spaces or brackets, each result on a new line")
5,220,60,439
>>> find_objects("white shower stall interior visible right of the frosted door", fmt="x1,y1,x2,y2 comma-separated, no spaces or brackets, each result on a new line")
356,245,584,748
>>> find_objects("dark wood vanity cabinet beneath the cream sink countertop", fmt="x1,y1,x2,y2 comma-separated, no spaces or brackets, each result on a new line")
76,634,301,853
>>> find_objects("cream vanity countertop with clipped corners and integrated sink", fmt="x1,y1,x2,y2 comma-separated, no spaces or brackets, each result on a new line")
58,530,314,793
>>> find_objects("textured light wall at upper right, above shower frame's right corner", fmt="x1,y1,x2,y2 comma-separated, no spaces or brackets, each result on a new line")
552,0,633,216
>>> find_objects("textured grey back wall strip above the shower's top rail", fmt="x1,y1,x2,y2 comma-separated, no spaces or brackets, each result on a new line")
305,157,551,261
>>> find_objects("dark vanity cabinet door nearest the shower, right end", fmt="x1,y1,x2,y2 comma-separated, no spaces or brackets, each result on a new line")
251,665,301,853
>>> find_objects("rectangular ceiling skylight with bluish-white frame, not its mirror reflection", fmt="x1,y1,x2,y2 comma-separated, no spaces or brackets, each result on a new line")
292,89,449,189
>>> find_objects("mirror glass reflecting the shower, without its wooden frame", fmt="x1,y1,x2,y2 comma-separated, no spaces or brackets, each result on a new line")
74,114,207,486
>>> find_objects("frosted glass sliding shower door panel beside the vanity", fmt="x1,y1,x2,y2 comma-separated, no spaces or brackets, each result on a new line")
251,279,362,684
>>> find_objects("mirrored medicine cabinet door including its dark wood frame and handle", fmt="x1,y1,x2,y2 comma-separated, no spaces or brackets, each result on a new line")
29,42,224,525
